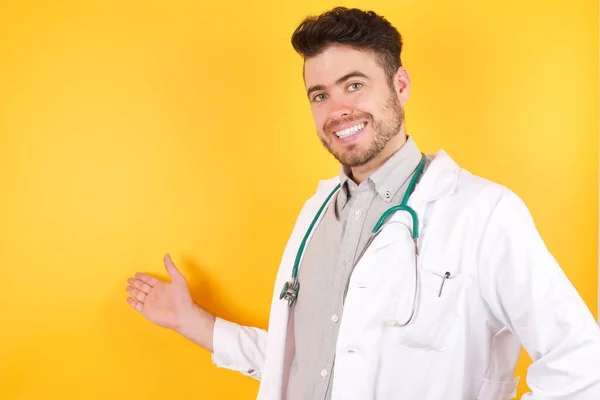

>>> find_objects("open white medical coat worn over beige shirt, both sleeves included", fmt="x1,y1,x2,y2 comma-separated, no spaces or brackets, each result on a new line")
212,150,600,400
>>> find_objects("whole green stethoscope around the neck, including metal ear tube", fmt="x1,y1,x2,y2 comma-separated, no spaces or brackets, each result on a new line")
279,154,427,326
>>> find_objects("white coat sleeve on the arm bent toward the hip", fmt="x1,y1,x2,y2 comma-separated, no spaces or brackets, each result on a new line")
479,191,600,400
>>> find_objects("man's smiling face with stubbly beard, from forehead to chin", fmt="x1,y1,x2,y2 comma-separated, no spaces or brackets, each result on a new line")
304,46,404,167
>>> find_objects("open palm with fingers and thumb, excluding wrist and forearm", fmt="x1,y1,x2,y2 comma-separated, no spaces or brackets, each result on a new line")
127,254,194,329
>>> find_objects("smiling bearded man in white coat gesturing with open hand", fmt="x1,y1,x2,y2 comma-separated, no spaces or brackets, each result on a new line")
127,8,600,400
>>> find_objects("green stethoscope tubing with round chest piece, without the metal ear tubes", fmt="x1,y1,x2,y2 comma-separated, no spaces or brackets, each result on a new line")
279,155,427,306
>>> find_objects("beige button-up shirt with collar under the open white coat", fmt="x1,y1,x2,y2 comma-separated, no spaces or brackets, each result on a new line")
286,137,427,400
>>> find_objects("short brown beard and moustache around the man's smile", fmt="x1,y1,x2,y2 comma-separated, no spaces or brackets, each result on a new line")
319,94,404,167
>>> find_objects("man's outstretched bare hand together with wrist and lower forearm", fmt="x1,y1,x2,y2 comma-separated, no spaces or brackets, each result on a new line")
126,254,215,351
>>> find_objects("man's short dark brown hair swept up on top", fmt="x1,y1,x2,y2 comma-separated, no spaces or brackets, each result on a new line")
292,7,402,82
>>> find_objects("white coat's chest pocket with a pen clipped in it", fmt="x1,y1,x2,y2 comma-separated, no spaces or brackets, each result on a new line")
392,268,467,351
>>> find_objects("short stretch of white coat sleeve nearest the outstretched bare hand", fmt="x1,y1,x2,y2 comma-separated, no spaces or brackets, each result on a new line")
212,317,267,380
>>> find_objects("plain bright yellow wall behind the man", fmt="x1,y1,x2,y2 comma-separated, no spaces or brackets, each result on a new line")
0,0,598,400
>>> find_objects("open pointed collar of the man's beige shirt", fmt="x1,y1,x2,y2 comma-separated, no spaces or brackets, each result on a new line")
339,136,422,207
